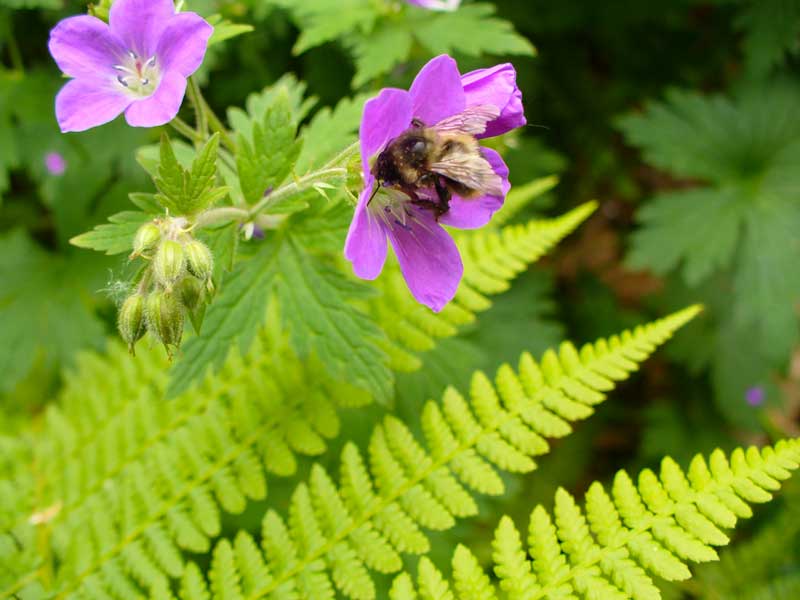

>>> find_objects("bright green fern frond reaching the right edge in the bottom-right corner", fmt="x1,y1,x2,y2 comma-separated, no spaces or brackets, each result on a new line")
391,440,800,600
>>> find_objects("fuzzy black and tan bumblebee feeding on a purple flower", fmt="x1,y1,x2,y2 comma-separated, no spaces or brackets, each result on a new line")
372,105,503,219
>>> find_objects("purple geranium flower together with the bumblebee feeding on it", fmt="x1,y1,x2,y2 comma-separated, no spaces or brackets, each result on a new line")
344,55,526,312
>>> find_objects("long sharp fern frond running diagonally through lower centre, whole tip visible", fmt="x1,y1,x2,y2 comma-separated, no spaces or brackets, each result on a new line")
178,307,699,600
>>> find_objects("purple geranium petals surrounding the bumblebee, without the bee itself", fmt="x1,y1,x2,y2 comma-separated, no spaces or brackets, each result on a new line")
344,55,525,312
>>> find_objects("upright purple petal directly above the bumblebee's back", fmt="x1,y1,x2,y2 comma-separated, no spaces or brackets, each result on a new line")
409,54,467,125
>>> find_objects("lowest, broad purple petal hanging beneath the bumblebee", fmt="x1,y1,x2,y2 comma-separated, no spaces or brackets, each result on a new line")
387,207,464,312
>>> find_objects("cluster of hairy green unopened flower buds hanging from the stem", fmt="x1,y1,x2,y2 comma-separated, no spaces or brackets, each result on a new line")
118,217,214,356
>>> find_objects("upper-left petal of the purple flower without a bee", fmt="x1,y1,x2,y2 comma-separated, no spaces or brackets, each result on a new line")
48,15,125,78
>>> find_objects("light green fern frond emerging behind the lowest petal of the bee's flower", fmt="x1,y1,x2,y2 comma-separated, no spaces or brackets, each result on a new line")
369,200,597,371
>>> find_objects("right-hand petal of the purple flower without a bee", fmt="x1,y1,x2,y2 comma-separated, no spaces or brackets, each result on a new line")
156,12,214,77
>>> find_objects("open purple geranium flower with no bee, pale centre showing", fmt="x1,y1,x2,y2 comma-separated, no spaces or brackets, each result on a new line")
49,0,214,132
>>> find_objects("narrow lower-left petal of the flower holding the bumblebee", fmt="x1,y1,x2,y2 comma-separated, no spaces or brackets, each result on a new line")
344,184,387,279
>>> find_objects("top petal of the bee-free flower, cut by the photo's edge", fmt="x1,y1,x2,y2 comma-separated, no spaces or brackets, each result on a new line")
108,0,175,60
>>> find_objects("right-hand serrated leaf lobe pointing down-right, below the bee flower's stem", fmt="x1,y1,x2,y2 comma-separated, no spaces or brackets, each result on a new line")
278,239,394,404
